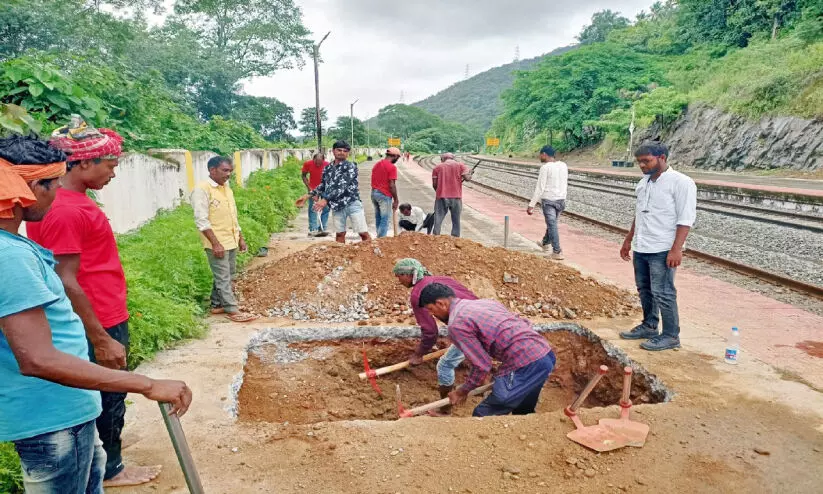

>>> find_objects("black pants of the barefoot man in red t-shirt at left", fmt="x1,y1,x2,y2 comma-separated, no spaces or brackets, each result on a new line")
89,321,129,480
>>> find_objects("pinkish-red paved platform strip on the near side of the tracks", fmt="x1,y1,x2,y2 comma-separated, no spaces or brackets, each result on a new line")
384,159,823,390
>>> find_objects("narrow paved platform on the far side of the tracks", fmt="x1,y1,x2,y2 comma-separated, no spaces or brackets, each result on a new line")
474,156,823,197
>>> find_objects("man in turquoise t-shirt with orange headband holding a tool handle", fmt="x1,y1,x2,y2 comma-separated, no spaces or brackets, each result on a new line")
0,136,191,494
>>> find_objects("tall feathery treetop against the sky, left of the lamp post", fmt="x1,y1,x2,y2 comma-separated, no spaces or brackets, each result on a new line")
174,0,311,80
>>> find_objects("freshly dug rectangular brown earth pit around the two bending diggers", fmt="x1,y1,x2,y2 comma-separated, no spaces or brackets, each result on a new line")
234,323,672,424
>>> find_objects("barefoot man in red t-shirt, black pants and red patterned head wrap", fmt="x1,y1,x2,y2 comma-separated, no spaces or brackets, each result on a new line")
26,121,160,487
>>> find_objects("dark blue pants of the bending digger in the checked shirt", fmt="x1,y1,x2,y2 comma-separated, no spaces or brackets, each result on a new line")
472,351,556,417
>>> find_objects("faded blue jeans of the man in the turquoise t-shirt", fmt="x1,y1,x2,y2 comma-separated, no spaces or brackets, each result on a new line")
14,420,106,494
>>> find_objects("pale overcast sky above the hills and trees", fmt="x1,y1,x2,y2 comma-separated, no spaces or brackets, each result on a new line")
245,0,653,127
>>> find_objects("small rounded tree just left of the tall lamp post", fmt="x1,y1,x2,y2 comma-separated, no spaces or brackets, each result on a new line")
232,95,297,142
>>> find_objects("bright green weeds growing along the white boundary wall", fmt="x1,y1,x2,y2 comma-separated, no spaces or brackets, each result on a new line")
0,158,305,494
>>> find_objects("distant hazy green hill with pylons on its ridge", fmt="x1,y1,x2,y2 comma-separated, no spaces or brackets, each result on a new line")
412,46,574,130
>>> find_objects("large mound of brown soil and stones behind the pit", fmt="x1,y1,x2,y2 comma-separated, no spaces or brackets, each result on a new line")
237,234,637,323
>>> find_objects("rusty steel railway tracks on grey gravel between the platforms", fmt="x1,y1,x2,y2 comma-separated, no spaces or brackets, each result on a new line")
417,156,823,300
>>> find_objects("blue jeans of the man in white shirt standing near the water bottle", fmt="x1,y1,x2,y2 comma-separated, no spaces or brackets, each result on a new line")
634,251,680,338
